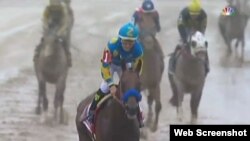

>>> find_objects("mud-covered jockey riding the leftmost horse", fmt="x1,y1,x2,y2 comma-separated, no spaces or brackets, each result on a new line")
34,0,72,67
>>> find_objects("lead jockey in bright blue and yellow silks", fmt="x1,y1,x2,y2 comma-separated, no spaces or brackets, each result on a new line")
88,23,143,127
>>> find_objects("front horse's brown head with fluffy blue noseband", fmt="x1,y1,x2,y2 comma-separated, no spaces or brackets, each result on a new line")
118,62,142,119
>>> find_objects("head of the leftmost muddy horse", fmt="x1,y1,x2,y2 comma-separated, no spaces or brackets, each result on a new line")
43,30,62,56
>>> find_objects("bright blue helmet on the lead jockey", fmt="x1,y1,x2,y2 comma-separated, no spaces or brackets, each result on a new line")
119,22,139,40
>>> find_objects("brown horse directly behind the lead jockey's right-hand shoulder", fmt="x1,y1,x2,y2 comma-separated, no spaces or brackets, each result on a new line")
140,34,164,132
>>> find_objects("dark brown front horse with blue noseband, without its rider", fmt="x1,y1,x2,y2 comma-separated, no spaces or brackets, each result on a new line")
75,60,142,141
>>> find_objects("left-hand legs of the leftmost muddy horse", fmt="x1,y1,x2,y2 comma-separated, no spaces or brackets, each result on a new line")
36,81,48,114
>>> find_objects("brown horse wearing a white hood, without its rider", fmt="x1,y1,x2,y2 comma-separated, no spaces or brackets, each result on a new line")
168,31,208,123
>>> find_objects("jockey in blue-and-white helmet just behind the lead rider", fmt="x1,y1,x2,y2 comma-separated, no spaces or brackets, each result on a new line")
132,0,161,36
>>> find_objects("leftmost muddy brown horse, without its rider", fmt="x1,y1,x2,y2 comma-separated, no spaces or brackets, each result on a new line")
34,29,68,124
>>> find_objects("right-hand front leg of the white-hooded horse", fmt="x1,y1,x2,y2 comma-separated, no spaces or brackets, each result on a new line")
190,91,202,123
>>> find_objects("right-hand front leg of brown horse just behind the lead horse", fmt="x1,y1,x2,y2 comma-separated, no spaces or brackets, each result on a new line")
149,84,162,132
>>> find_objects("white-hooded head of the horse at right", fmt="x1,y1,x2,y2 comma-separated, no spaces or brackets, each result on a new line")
189,31,208,61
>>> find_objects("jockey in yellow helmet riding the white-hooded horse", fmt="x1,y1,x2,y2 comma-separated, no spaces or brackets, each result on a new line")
170,0,209,73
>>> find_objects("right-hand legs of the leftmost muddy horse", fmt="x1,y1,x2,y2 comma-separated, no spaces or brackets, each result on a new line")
54,79,66,123
